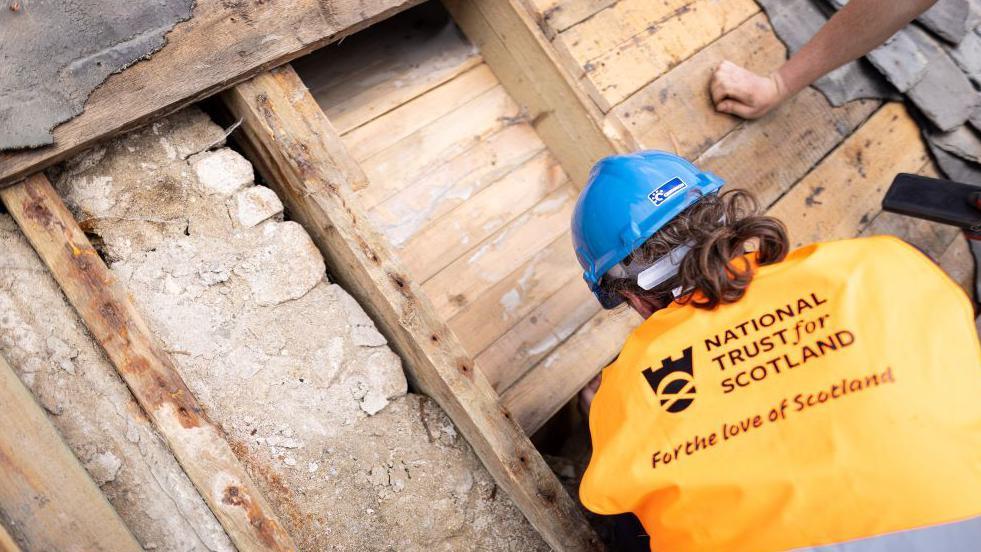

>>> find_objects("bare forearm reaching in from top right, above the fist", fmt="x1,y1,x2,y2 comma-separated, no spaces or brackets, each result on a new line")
775,0,937,98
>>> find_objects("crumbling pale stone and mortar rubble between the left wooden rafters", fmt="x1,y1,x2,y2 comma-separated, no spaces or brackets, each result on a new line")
21,108,547,551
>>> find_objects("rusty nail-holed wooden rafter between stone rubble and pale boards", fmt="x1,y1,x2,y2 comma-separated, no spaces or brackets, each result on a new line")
224,66,600,550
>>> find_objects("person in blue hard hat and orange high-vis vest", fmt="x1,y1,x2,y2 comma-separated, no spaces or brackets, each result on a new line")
572,152,981,552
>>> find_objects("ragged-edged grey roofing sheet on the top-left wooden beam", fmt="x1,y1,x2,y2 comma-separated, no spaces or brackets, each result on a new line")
0,0,194,151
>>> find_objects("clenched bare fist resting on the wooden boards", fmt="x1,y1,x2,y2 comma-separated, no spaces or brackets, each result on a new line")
709,61,784,119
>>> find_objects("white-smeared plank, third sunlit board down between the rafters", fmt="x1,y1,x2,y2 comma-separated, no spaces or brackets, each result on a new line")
368,123,545,249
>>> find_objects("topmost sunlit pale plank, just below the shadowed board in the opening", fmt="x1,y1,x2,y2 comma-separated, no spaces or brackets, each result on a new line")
344,64,498,161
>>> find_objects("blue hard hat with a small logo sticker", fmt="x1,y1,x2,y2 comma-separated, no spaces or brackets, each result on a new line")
572,151,724,309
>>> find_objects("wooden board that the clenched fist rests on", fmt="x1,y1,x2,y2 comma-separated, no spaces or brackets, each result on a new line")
610,13,786,159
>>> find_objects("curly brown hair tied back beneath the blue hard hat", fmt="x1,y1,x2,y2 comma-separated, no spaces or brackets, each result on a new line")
600,190,790,309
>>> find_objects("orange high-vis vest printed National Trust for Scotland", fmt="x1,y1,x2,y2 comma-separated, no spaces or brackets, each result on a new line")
580,237,981,552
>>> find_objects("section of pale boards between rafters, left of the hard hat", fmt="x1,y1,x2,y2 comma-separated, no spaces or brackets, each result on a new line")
301,6,595,434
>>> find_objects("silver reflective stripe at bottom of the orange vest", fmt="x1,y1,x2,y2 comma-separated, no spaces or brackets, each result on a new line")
797,517,981,552
